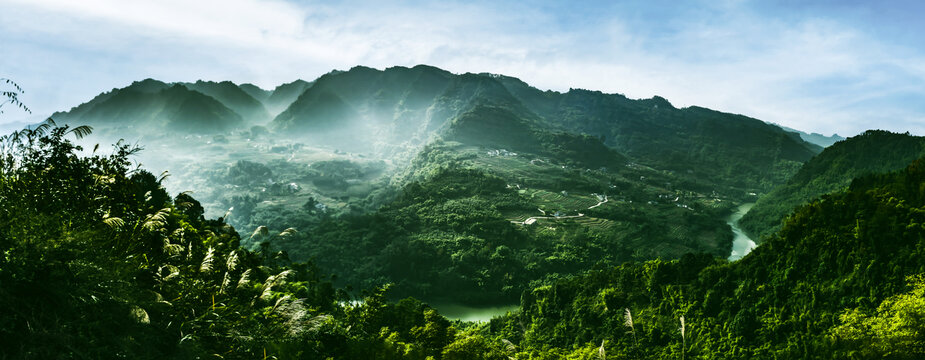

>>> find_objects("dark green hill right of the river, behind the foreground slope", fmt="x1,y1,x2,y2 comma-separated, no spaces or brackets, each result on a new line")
739,130,925,239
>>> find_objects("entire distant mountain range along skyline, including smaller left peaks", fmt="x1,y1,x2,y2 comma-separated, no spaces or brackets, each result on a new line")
55,65,821,196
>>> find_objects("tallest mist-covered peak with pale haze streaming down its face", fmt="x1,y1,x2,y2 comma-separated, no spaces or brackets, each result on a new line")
272,66,457,151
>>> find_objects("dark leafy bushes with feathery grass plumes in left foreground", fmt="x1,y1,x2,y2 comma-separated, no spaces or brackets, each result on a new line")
0,123,502,359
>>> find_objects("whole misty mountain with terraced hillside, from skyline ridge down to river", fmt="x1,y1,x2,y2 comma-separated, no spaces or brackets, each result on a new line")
36,65,821,303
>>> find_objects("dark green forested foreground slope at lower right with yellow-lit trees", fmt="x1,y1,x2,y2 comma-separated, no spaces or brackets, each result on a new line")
488,154,925,359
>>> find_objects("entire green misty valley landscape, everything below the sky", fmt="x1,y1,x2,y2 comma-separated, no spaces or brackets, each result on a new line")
0,65,925,360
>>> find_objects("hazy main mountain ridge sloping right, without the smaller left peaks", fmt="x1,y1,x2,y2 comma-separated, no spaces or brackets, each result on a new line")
272,66,821,194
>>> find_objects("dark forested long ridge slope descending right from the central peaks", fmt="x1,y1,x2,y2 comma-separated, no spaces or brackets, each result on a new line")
496,76,819,191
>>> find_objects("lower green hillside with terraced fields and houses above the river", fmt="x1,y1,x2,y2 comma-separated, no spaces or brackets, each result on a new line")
247,143,732,304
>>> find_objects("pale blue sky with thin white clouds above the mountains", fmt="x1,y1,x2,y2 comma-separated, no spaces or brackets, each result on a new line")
0,0,925,136
